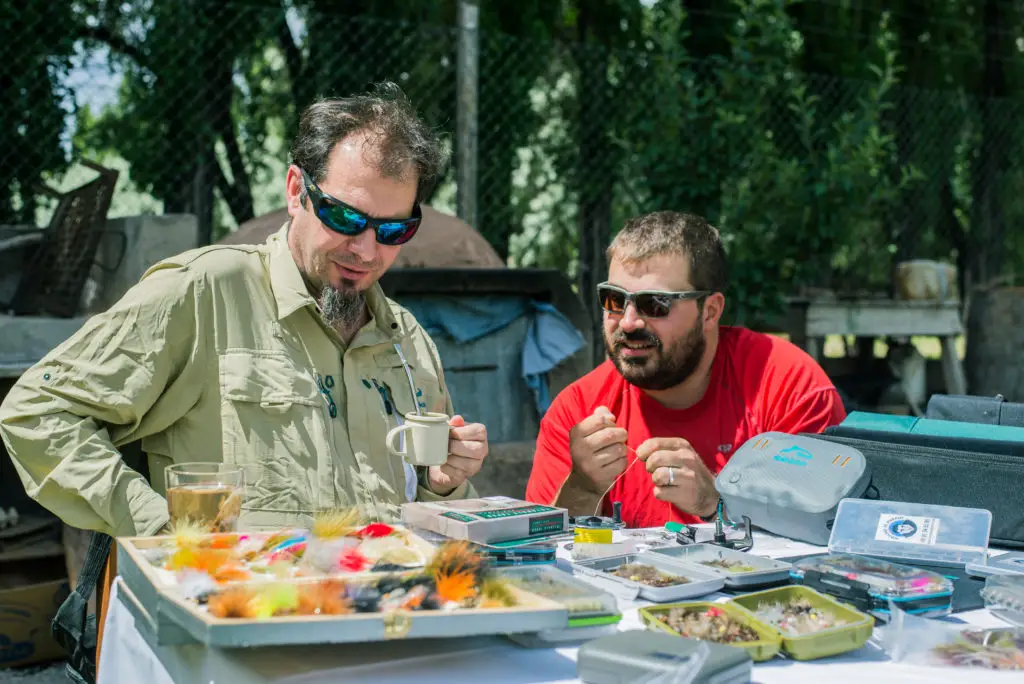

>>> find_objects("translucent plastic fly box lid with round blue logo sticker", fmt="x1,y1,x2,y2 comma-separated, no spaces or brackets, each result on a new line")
828,499,992,567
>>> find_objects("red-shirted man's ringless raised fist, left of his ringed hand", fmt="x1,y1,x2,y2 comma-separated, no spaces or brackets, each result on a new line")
569,407,628,495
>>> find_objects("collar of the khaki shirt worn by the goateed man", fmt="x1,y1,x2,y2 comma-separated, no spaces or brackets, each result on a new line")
266,222,401,343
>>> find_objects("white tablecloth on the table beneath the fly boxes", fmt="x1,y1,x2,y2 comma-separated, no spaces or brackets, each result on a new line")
97,525,1024,684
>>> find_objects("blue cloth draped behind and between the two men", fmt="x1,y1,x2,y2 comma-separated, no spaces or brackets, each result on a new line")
401,297,586,416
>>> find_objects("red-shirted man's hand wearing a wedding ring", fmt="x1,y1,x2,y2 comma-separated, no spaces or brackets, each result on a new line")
637,437,718,517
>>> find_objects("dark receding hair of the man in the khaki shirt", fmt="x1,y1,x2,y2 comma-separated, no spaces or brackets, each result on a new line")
291,81,449,202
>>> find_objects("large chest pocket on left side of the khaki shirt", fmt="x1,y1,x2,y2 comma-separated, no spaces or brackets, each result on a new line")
219,350,330,516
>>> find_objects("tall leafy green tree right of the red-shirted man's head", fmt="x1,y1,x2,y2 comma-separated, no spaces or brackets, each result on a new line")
715,0,912,319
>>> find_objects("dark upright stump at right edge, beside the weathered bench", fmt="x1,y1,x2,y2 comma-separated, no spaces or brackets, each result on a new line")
965,288,1024,401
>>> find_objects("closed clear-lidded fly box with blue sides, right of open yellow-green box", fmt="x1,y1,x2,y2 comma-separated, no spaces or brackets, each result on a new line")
790,554,953,619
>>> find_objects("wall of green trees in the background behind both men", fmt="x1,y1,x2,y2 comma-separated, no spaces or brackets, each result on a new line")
14,0,1024,322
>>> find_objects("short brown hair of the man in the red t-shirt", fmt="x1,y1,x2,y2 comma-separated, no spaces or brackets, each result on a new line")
607,211,729,293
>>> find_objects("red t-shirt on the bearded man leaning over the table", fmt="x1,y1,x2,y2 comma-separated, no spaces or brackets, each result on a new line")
526,326,846,527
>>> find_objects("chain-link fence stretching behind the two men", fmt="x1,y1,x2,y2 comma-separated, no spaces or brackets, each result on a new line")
0,0,1024,323
